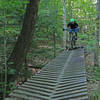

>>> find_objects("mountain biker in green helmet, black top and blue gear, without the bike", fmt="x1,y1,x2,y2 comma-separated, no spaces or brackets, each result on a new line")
67,18,79,40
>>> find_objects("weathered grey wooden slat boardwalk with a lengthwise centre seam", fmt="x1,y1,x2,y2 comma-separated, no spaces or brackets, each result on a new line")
5,48,88,100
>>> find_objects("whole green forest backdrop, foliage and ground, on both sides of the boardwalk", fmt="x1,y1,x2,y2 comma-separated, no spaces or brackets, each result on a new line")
0,0,100,100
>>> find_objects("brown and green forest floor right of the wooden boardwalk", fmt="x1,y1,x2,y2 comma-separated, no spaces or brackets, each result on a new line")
86,52,100,99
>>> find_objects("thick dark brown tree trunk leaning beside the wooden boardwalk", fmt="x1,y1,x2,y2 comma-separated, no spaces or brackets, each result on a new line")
8,0,40,81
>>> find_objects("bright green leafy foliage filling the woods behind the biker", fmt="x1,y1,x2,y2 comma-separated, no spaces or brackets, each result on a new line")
0,0,100,99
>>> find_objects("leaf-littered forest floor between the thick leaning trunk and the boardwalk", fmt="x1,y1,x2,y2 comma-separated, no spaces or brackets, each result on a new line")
27,42,62,75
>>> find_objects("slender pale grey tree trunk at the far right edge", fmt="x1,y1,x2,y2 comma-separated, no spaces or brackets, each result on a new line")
94,0,100,66
